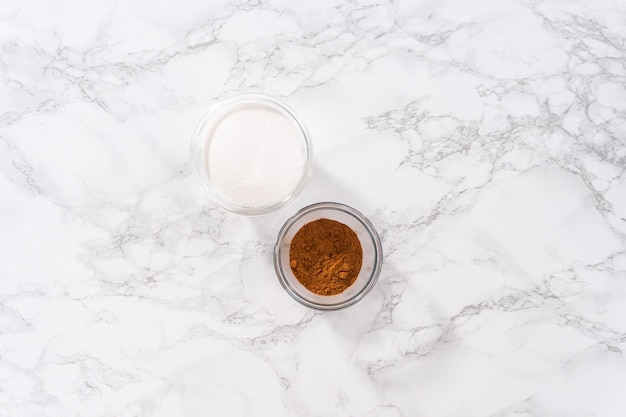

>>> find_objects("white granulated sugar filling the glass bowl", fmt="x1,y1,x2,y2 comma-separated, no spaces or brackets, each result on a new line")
207,105,306,209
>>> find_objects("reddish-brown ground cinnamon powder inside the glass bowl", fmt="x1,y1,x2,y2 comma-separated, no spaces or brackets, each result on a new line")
289,219,363,295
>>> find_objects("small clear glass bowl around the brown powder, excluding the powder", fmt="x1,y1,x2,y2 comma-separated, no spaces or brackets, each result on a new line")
274,202,383,310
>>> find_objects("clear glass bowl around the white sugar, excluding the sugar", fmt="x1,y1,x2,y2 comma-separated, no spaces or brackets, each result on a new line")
189,93,313,216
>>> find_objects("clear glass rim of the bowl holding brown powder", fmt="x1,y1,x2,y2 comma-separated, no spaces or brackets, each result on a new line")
273,201,383,311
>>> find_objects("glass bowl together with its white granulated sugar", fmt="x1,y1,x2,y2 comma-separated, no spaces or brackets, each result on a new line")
190,93,313,215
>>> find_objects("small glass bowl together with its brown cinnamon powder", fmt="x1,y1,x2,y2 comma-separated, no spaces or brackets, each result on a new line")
274,202,383,310
